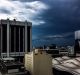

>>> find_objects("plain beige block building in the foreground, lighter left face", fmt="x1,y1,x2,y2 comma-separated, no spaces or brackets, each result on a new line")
24,49,53,75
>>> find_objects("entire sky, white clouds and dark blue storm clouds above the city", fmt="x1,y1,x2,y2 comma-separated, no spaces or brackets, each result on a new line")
0,0,80,46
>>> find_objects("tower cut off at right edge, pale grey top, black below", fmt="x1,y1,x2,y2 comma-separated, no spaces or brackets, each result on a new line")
75,30,80,53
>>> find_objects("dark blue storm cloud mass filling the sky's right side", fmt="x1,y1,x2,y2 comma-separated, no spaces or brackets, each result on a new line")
33,0,80,45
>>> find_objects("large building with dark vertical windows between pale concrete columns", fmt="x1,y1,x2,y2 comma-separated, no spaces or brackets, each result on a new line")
0,19,32,60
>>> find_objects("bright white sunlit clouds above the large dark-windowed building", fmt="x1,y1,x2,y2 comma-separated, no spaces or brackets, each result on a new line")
0,0,49,25
